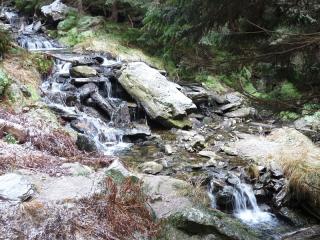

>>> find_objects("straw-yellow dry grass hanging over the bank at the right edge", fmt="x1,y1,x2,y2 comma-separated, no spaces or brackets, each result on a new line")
269,129,320,210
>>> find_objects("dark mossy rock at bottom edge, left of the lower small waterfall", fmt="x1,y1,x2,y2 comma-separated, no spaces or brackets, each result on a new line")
169,208,262,240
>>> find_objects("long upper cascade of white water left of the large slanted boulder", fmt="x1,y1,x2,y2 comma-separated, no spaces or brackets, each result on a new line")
2,8,150,155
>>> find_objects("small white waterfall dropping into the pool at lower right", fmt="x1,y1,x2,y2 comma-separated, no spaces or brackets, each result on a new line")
233,183,274,225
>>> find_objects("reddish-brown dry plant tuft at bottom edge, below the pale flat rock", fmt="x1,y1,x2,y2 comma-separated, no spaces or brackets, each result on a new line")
76,178,159,239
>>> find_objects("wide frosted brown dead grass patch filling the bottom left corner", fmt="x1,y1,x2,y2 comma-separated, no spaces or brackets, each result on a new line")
0,178,159,240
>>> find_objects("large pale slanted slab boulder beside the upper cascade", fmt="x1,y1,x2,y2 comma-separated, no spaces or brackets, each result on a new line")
119,62,196,128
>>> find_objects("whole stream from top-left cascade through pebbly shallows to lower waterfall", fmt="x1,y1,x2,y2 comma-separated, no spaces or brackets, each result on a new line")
1,6,318,239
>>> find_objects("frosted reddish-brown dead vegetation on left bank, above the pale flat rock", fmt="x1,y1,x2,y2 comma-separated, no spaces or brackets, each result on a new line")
0,110,113,175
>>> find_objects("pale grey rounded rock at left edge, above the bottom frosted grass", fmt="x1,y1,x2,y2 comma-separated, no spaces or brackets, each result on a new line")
0,173,35,202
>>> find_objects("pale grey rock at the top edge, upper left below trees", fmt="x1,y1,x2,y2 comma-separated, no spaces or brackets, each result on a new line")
41,0,71,21
